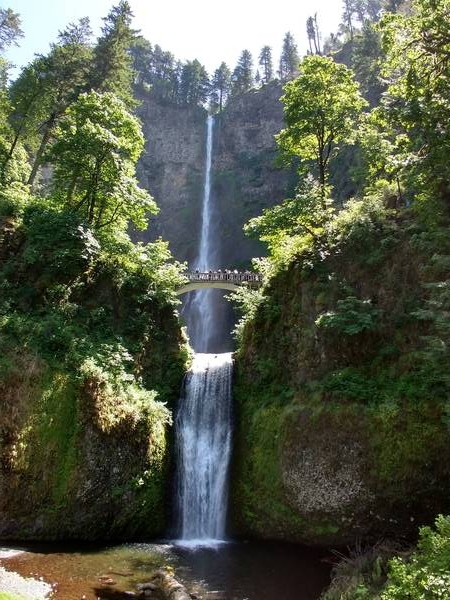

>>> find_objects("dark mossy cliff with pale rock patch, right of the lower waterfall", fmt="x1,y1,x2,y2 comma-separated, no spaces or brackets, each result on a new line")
232,207,450,545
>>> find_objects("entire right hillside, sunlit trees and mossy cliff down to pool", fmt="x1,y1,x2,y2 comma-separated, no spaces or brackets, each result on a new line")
233,0,450,576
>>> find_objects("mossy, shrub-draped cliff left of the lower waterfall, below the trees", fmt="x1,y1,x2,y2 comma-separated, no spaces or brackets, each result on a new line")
0,213,186,540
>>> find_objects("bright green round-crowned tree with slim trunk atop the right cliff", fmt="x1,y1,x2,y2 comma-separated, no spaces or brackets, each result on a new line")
277,55,367,196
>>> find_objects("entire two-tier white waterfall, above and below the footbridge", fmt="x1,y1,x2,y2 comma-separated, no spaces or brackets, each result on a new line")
175,116,232,545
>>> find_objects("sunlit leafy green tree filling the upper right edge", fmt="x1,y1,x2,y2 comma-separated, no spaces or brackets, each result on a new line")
381,0,450,206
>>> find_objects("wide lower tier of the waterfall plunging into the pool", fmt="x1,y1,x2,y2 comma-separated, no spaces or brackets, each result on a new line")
175,353,232,545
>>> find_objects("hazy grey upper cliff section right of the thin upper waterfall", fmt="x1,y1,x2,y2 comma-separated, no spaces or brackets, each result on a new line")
212,83,296,266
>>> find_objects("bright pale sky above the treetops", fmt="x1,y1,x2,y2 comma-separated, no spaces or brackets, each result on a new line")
0,0,342,76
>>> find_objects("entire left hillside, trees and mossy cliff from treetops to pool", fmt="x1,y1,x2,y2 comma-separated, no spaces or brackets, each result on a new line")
0,2,187,539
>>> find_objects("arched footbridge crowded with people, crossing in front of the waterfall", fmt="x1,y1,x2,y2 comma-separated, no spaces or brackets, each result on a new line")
177,270,262,296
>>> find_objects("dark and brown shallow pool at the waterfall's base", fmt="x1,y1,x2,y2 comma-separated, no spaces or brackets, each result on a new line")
0,542,332,600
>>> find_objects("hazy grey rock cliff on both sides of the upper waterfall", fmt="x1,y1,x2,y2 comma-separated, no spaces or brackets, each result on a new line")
134,83,293,268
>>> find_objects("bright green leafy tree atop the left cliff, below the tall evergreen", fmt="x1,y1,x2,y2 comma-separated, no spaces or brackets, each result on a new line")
47,91,156,230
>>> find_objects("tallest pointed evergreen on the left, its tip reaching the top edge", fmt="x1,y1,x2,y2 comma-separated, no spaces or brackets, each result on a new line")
91,0,136,108
